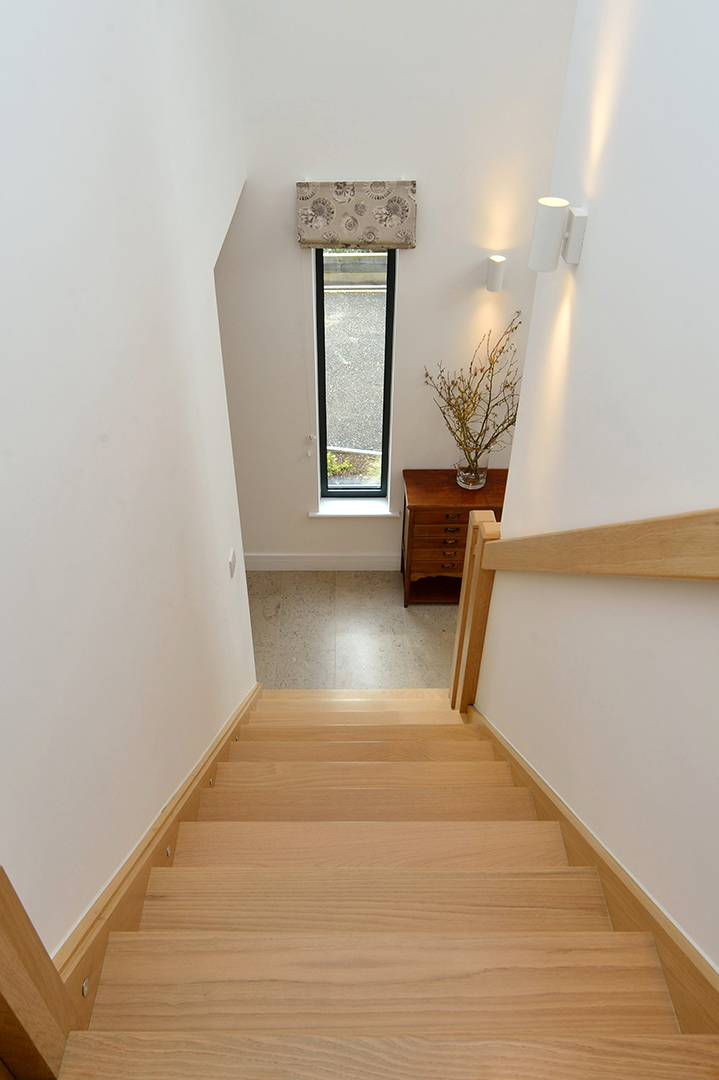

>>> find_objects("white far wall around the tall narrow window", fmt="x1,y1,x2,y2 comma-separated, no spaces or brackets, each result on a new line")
217,0,574,567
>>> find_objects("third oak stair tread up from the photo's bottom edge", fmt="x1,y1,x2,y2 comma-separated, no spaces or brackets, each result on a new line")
140,867,611,934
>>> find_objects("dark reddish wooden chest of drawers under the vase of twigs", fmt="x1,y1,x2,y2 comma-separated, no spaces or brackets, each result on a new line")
402,469,506,607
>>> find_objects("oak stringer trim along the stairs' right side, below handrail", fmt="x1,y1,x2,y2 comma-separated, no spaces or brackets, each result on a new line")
467,705,719,1035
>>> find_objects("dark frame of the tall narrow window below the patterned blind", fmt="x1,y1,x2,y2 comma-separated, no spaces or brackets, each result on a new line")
314,247,397,499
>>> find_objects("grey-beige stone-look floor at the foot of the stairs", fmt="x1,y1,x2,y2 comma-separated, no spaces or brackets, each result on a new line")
247,570,458,690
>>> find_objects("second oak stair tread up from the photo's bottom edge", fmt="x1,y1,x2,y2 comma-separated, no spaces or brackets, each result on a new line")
86,931,678,1036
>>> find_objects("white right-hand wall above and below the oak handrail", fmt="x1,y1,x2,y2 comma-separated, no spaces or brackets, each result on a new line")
478,0,719,964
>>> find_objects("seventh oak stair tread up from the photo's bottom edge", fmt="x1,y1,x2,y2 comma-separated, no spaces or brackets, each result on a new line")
230,739,494,761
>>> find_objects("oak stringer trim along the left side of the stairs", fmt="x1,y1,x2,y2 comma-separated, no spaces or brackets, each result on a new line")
52,683,262,1028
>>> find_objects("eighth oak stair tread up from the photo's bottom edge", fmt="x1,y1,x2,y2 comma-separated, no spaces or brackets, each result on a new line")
240,720,479,743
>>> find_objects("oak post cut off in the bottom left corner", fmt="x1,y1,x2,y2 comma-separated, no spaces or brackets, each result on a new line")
0,867,81,1080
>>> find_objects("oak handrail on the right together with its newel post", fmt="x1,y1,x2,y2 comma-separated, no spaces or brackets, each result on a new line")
449,509,719,713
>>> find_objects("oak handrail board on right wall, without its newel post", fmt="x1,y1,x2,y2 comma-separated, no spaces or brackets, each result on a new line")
481,509,719,581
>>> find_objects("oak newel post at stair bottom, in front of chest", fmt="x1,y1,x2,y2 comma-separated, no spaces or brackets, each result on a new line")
449,510,500,713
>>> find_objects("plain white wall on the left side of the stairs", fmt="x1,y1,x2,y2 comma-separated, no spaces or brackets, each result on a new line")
0,0,254,949
